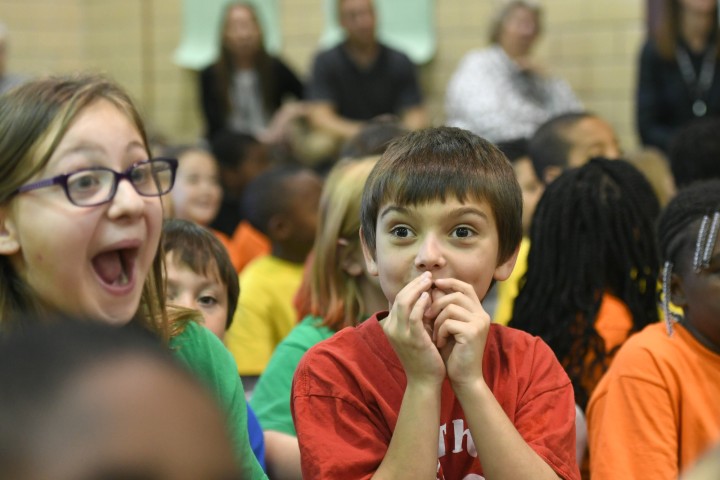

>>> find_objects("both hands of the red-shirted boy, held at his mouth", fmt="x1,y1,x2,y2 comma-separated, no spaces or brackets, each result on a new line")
383,272,490,389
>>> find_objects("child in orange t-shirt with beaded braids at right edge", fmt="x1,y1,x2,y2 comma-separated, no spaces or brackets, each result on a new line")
588,180,720,480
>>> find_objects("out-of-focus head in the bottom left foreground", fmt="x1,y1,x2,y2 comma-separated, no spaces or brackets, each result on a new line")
0,315,244,480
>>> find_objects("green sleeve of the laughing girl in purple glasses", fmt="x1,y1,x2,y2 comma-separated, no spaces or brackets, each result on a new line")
170,322,267,480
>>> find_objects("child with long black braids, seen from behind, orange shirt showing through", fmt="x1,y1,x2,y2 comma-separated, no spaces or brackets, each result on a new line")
509,159,660,410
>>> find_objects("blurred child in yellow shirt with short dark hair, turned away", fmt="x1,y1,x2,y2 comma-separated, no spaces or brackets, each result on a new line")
225,166,322,386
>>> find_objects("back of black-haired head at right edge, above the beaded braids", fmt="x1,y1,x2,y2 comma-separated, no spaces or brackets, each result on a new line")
668,117,720,188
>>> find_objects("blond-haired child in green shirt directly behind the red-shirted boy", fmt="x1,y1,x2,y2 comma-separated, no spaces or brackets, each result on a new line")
251,157,387,479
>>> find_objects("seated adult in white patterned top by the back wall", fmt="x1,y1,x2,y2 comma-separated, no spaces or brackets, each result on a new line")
445,0,582,142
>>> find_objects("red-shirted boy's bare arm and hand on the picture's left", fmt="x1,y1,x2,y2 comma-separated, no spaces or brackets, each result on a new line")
372,273,445,479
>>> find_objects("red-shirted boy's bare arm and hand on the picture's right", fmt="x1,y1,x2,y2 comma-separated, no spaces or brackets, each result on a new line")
429,278,558,479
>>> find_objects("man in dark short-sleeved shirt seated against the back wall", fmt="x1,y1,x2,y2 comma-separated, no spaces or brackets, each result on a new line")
307,0,427,141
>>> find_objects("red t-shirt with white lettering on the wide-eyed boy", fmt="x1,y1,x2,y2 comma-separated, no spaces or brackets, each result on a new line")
292,313,580,479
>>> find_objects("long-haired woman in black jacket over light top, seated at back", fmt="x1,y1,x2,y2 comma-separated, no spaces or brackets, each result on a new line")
199,2,303,143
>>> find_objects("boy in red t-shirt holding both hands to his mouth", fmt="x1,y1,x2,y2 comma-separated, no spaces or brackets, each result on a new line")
292,127,579,479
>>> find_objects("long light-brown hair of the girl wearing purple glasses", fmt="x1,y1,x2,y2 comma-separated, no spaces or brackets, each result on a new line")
0,74,179,341
